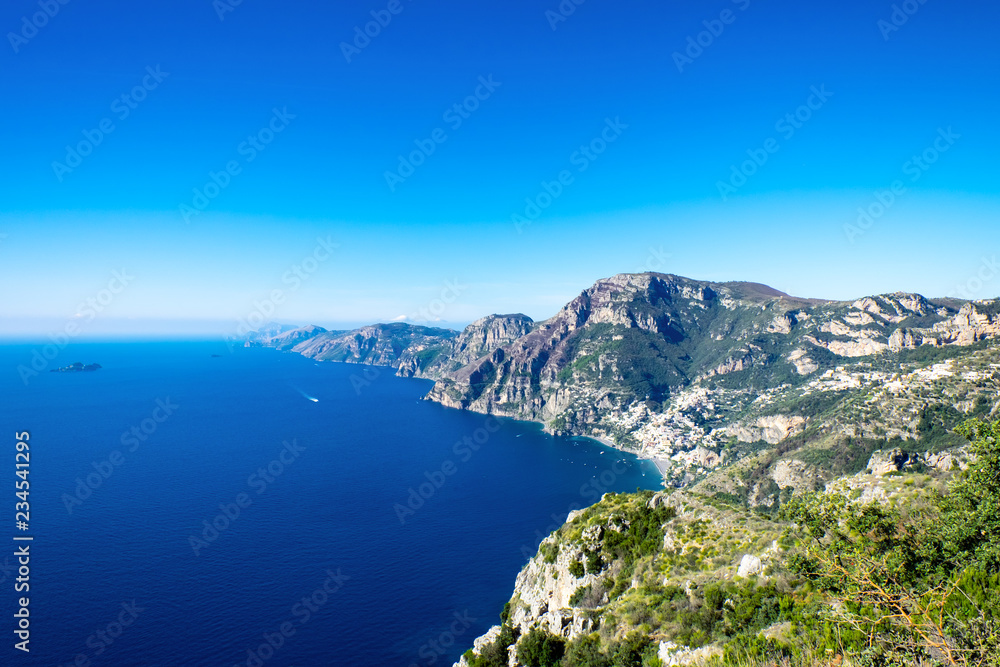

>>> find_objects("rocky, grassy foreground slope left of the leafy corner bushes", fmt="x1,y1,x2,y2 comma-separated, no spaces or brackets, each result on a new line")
456,438,1000,667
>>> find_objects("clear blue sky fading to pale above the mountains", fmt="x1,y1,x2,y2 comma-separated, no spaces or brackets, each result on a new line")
0,0,1000,335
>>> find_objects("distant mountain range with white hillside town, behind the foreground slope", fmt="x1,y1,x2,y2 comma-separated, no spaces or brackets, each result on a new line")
253,273,1000,506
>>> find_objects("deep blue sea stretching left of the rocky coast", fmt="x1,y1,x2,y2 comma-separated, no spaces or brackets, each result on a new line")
0,342,659,667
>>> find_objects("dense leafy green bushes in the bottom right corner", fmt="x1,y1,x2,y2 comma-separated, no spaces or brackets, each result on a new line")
786,420,1000,665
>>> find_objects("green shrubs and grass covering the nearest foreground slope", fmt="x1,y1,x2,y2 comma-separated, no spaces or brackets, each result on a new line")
470,420,1000,667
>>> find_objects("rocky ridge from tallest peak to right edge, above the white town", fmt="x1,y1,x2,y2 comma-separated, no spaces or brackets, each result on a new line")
429,274,1000,435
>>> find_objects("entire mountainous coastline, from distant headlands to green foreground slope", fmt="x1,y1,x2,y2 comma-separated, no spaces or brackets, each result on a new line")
242,273,1000,667
